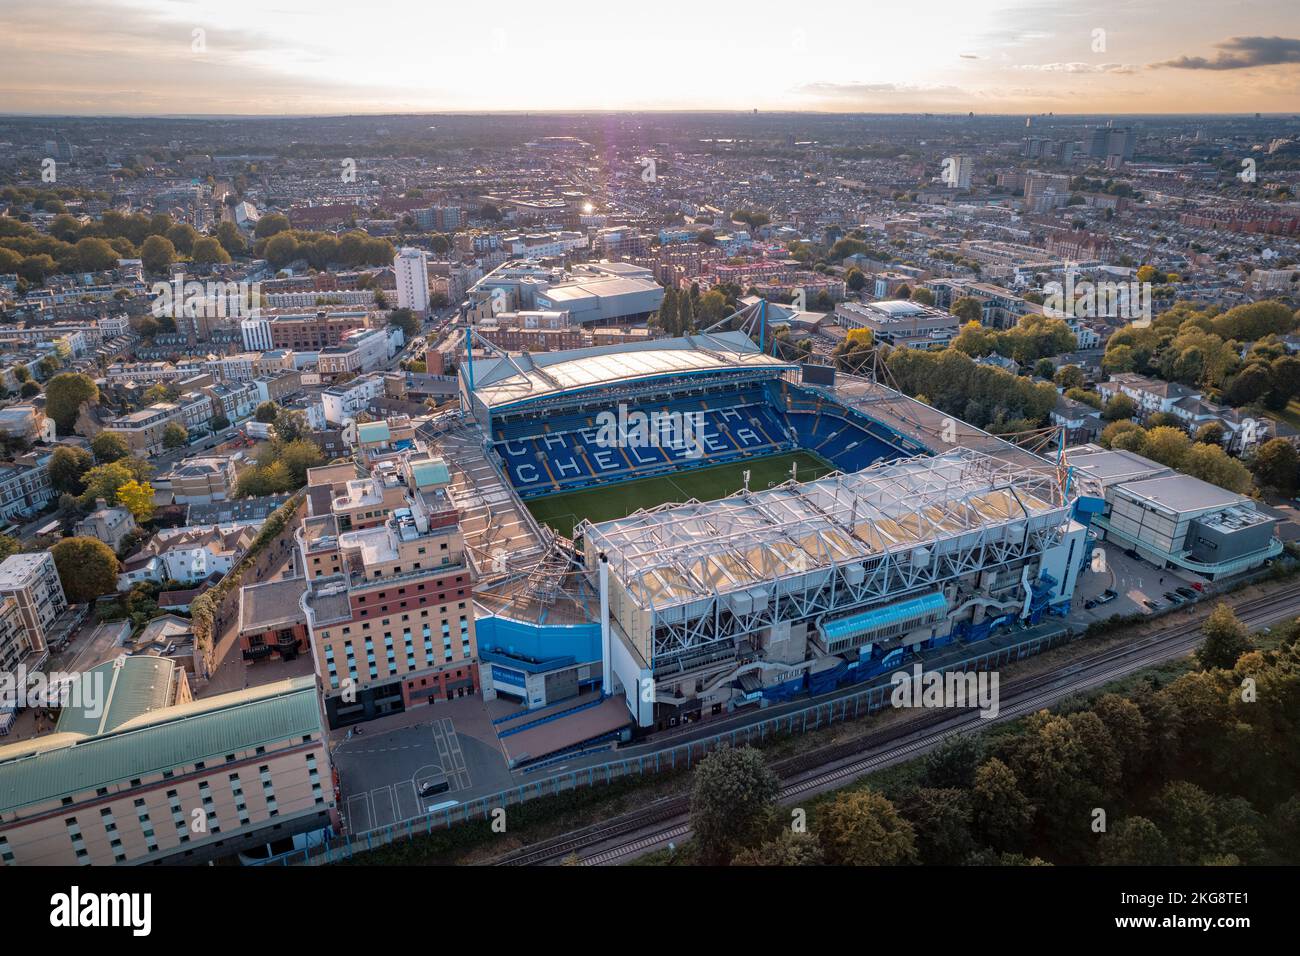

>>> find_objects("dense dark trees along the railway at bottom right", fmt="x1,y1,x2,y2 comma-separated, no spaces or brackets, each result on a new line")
688,605,1300,865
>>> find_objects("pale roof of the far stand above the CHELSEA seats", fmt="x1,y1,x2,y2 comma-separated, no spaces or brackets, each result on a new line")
475,332,797,410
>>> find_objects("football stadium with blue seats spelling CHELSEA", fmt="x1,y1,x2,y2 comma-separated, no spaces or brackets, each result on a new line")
421,321,1088,763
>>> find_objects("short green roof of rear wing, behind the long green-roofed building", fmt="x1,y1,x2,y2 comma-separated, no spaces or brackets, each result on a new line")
57,654,178,737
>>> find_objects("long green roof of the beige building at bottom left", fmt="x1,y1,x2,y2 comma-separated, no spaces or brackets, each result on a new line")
0,678,321,813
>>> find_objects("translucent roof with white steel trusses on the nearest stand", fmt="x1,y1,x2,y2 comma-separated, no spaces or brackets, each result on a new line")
585,449,1066,609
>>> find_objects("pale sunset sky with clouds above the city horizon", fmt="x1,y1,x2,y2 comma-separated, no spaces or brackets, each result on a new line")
0,0,1300,114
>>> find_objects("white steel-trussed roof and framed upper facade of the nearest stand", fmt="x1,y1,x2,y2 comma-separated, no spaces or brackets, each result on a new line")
582,447,1069,674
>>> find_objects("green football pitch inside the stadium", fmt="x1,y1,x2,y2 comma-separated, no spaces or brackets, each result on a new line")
525,451,835,537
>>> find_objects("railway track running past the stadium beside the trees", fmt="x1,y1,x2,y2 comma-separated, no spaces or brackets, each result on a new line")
497,584,1300,866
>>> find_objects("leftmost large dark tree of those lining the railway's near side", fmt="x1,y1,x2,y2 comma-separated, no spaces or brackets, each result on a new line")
690,747,780,862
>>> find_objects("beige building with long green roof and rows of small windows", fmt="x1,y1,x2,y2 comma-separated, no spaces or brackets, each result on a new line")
0,671,338,866
